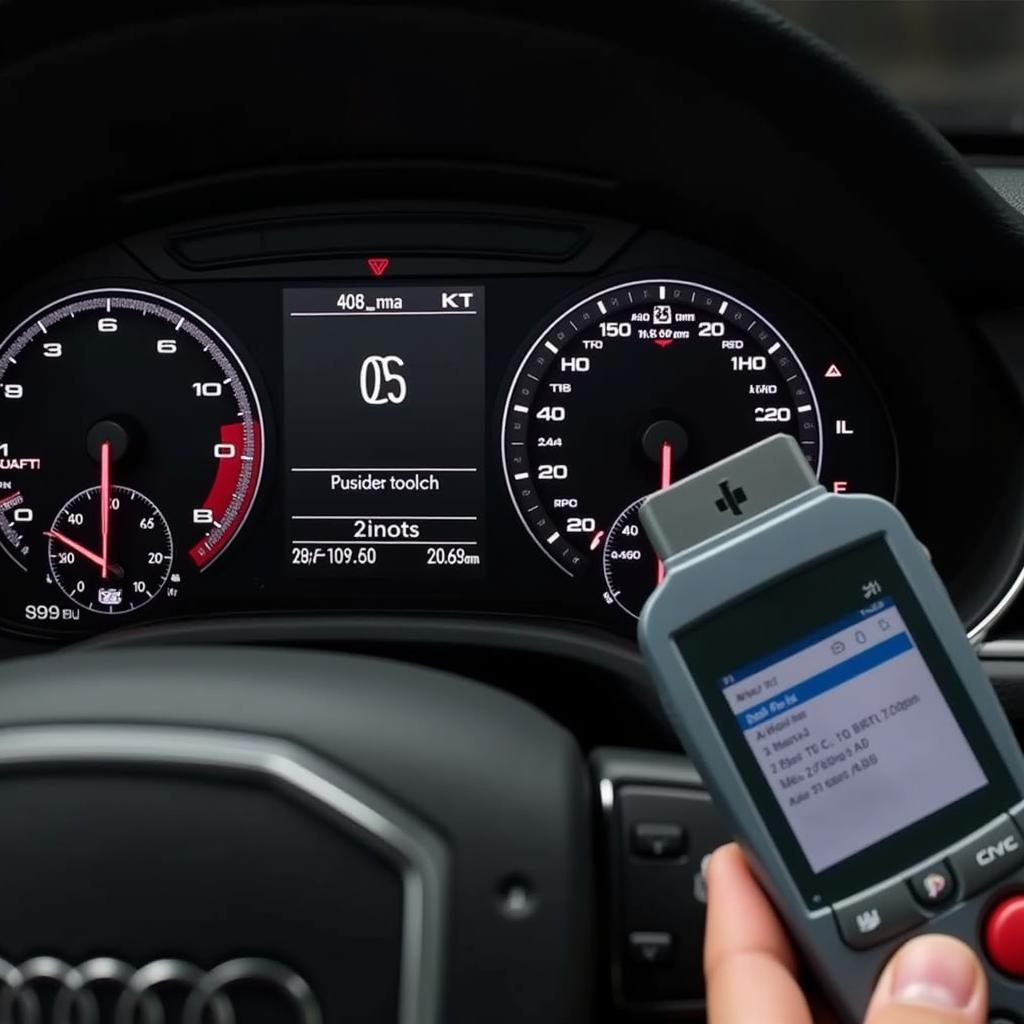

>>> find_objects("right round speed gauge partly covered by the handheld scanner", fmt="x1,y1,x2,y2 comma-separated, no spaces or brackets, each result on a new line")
503,279,895,615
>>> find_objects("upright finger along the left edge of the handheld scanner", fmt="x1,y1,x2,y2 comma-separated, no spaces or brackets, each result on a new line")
705,844,811,1024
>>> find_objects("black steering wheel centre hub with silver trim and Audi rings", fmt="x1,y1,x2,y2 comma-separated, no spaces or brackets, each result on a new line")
0,648,594,1024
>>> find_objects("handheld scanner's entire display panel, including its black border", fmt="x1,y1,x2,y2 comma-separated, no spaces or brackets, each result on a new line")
676,539,1016,902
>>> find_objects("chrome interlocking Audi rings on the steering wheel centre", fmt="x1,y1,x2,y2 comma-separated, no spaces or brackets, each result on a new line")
0,956,324,1024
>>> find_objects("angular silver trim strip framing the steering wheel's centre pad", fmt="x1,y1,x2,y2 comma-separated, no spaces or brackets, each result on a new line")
0,725,447,1024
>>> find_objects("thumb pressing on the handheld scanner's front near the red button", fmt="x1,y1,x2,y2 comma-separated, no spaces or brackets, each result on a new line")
864,935,988,1024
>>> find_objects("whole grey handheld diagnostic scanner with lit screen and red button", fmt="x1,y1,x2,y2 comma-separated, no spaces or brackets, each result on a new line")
639,434,1024,1022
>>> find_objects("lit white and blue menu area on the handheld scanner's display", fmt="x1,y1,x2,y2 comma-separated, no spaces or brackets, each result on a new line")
721,598,988,871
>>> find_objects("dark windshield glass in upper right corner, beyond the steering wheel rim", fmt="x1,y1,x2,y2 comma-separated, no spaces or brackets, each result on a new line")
764,0,1024,147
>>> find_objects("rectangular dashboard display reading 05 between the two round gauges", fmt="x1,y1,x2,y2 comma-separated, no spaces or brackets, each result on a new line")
284,285,485,579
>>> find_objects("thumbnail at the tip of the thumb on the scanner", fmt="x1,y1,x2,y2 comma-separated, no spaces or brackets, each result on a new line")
892,935,980,1010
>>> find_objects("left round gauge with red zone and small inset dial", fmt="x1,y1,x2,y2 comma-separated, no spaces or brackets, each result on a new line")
0,289,264,628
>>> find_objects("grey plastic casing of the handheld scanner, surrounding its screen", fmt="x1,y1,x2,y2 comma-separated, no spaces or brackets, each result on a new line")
639,434,1024,1024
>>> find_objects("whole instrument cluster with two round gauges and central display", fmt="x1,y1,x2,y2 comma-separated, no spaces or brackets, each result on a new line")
0,202,929,637
